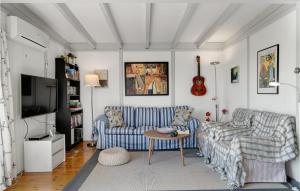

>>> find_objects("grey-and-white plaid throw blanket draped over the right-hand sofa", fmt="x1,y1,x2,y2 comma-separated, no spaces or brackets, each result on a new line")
202,109,298,187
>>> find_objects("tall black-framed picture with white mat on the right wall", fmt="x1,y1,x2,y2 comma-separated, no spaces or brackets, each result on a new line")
257,44,279,94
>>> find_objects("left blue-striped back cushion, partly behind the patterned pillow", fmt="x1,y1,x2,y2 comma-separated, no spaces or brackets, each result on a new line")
104,106,135,127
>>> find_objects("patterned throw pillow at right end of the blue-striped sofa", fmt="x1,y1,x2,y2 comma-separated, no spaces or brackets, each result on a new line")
172,108,192,127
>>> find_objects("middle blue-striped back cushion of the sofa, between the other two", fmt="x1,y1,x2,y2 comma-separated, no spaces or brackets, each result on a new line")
135,107,159,127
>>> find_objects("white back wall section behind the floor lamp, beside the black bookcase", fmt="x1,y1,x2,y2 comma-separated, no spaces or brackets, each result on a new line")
76,51,120,140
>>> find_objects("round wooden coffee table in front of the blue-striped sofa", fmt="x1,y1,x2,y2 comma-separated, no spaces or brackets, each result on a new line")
144,130,190,166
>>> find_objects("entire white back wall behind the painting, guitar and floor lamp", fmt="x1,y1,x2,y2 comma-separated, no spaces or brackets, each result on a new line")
76,51,223,140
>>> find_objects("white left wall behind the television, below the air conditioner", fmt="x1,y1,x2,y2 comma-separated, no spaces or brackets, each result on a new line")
1,9,65,173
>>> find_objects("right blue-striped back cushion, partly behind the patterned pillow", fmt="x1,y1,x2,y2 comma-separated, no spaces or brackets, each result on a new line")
159,106,189,127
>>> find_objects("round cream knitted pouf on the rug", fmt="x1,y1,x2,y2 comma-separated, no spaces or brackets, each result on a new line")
98,147,130,166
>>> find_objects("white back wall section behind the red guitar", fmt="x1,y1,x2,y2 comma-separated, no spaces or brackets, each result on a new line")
175,51,223,119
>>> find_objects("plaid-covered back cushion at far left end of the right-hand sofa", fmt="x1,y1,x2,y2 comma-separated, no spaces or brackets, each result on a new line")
232,108,255,128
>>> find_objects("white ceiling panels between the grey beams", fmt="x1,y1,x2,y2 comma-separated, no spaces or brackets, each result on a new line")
3,2,294,49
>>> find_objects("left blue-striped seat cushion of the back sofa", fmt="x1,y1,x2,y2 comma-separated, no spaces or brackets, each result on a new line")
104,126,156,135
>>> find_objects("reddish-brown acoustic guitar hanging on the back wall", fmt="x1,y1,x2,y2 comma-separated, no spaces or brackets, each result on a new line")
191,56,206,96
